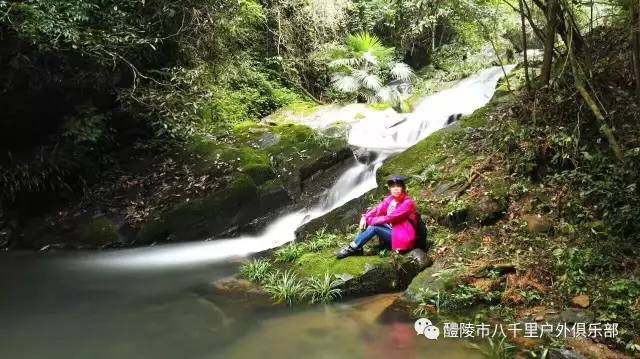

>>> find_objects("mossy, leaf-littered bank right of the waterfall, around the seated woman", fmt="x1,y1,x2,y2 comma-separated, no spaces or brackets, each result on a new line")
242,52,640,358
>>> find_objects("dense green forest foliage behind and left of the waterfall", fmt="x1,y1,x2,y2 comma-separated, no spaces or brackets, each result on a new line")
0,0,518,246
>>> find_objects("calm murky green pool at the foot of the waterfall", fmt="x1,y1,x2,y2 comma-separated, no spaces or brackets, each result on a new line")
0,254,480,359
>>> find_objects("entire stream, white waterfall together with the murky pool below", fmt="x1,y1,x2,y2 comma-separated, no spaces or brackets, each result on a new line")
0,65,513,359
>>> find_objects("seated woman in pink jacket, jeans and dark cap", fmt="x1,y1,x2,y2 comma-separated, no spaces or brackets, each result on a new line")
336,176,417,259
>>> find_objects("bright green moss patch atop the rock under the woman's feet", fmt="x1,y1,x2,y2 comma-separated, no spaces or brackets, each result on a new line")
293,249,388,277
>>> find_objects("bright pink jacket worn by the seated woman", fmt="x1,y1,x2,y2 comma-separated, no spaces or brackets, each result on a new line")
364,195,417,250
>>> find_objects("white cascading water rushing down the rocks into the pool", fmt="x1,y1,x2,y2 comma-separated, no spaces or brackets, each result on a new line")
86,65,514,269
